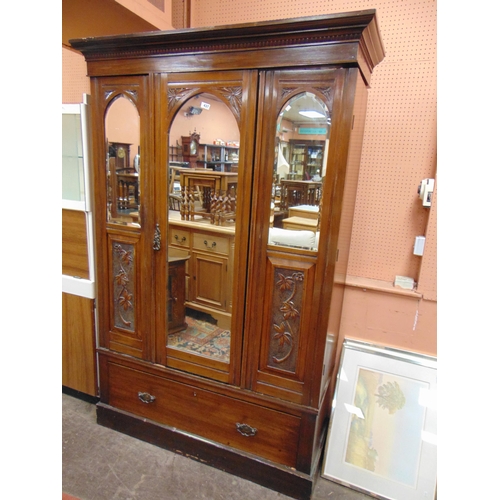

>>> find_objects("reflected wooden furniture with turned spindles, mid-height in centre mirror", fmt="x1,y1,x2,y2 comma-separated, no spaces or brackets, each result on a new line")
180,169,238,225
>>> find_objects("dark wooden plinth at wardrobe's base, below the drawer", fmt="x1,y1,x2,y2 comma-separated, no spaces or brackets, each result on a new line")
96,403,319,500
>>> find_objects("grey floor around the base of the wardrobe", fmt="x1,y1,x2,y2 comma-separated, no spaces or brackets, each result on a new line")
62,394,371,500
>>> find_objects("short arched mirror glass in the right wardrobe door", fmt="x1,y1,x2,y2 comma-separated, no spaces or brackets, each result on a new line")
268,92,331,251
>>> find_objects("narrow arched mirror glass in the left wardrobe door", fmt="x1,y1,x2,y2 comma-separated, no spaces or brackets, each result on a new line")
105,94,141,225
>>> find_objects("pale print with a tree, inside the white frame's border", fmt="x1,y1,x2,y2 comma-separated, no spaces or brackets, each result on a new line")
345,368,428,487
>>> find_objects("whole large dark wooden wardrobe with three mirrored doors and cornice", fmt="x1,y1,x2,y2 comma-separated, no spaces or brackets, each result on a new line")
71,10,384,498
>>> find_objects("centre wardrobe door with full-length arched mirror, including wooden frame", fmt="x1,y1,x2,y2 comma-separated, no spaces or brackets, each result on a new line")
155,71,257,383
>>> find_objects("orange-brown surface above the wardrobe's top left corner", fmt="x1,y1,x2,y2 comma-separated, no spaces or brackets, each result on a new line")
62,0,158,46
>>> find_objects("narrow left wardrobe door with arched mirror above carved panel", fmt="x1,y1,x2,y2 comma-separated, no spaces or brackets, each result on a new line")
92,77,154,359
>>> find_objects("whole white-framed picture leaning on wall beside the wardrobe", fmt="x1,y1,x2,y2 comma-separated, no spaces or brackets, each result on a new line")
322,339,437,500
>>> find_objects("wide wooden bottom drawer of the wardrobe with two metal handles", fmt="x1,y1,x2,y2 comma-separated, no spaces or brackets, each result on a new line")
108,362,300,467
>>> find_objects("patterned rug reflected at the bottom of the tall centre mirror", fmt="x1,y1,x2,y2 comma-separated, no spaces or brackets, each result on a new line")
168,316,231,363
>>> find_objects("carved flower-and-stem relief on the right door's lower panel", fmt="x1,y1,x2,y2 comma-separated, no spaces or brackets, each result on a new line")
273,272,304,363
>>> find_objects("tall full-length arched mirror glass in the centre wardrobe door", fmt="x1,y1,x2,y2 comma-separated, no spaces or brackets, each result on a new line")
167,93,242,369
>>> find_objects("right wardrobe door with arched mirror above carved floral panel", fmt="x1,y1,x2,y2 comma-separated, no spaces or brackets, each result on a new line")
245,70,344,403
